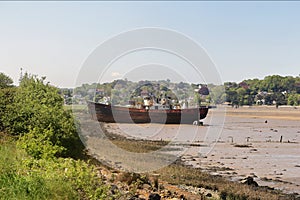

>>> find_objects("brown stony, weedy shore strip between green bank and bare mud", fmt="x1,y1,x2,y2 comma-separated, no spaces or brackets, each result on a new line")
82,129,288,200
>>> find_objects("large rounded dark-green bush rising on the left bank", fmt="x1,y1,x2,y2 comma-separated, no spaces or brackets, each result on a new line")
0,74,83,158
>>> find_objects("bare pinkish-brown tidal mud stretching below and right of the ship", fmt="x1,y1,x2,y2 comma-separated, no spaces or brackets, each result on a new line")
79,107,300,198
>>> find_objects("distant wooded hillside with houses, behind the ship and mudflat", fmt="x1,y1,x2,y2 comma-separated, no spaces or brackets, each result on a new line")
72,75,300,106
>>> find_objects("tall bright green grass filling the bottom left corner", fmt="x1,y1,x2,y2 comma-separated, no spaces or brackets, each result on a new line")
0,143,79,200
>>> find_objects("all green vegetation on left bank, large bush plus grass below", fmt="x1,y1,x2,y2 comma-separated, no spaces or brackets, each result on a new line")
0,74,113,200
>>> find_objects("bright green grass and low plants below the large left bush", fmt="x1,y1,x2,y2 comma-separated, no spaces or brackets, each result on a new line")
0,134,109,200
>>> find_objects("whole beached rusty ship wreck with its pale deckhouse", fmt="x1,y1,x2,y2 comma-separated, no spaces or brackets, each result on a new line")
88,84,210,124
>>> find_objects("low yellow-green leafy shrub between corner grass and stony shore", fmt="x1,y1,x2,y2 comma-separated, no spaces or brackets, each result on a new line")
23,158,109,199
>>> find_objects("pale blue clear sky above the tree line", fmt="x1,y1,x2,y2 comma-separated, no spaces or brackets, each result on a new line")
0,1,300,87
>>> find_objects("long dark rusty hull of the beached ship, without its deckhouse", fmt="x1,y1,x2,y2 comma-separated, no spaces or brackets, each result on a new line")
88,102,209,124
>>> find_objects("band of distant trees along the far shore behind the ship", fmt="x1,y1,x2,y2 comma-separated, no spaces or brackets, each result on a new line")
75,75,300,105
